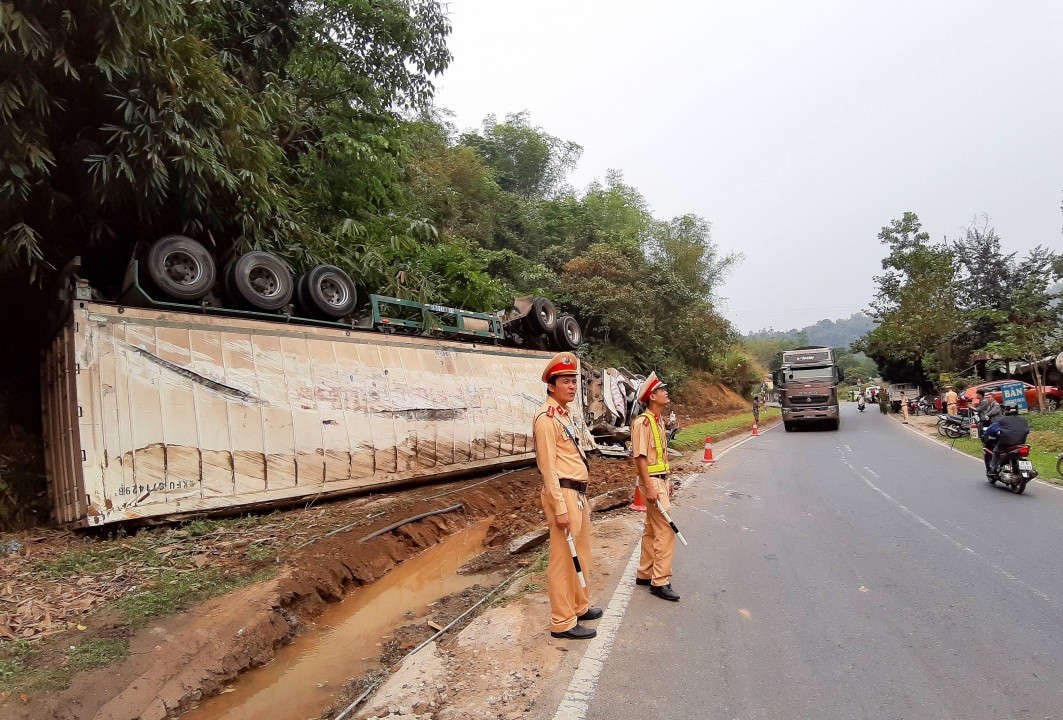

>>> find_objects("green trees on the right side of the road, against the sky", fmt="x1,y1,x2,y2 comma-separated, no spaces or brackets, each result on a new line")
854,213,1063,384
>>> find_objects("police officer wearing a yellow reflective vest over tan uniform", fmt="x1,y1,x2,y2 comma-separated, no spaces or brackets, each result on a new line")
631,372,679,602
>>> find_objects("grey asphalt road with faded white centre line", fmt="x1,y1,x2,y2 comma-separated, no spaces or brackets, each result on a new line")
587,404,1063,720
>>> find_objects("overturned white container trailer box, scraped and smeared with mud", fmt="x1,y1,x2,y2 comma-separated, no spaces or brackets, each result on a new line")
41,301,561,526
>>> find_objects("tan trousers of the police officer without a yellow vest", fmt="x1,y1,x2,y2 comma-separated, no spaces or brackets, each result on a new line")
541,487,591,633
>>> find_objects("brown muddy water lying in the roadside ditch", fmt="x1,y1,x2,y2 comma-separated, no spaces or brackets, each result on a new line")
183,520,501,720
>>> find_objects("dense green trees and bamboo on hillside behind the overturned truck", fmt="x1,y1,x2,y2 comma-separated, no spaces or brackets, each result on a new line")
0,0,757,523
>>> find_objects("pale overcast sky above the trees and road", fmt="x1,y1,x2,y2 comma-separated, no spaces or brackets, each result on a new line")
436,0,1063,332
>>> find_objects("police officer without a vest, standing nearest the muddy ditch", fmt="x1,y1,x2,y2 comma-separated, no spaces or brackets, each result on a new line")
532,352,602,640
